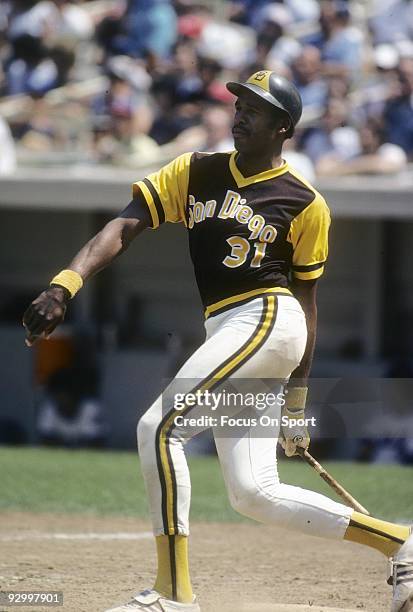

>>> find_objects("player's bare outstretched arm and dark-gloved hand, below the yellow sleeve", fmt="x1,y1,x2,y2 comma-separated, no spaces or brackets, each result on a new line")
23,198,151,346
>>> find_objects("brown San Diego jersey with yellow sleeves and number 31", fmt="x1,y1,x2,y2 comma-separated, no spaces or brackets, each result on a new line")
133,151,330,316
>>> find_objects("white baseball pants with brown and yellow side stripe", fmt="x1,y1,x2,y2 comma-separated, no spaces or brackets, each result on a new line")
138,293,353,539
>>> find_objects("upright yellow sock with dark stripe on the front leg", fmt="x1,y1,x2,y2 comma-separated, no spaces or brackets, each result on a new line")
154,535,193,603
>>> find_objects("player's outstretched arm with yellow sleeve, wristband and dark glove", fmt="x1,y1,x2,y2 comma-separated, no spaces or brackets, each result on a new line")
23,153,192,346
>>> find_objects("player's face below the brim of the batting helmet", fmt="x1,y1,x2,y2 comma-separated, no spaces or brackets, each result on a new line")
232,91,289,155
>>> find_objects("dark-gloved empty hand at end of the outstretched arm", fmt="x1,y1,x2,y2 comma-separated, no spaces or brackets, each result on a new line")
23,287,70,346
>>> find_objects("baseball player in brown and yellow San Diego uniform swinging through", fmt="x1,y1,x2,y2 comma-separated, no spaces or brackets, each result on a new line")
24,71,413,612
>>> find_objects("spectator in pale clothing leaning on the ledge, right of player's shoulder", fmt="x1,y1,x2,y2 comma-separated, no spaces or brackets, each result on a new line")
317,118,407,176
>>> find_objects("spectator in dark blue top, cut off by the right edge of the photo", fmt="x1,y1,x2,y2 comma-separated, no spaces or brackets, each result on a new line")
384,58,413,159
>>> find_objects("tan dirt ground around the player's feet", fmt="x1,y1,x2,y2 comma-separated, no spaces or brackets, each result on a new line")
0,513,391,612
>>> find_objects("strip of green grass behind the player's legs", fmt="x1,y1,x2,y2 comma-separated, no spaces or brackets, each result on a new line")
0,447,413,521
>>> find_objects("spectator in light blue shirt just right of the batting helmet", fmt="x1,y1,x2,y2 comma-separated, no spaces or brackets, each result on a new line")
292,45,328,112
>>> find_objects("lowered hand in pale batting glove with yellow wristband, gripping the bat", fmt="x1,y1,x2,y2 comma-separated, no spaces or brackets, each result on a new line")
280,387,310,457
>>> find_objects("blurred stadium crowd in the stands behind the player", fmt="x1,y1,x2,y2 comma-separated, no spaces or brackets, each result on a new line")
0,0,413,180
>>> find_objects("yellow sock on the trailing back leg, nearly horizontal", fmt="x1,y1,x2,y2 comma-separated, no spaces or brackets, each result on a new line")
344,512,410,557
